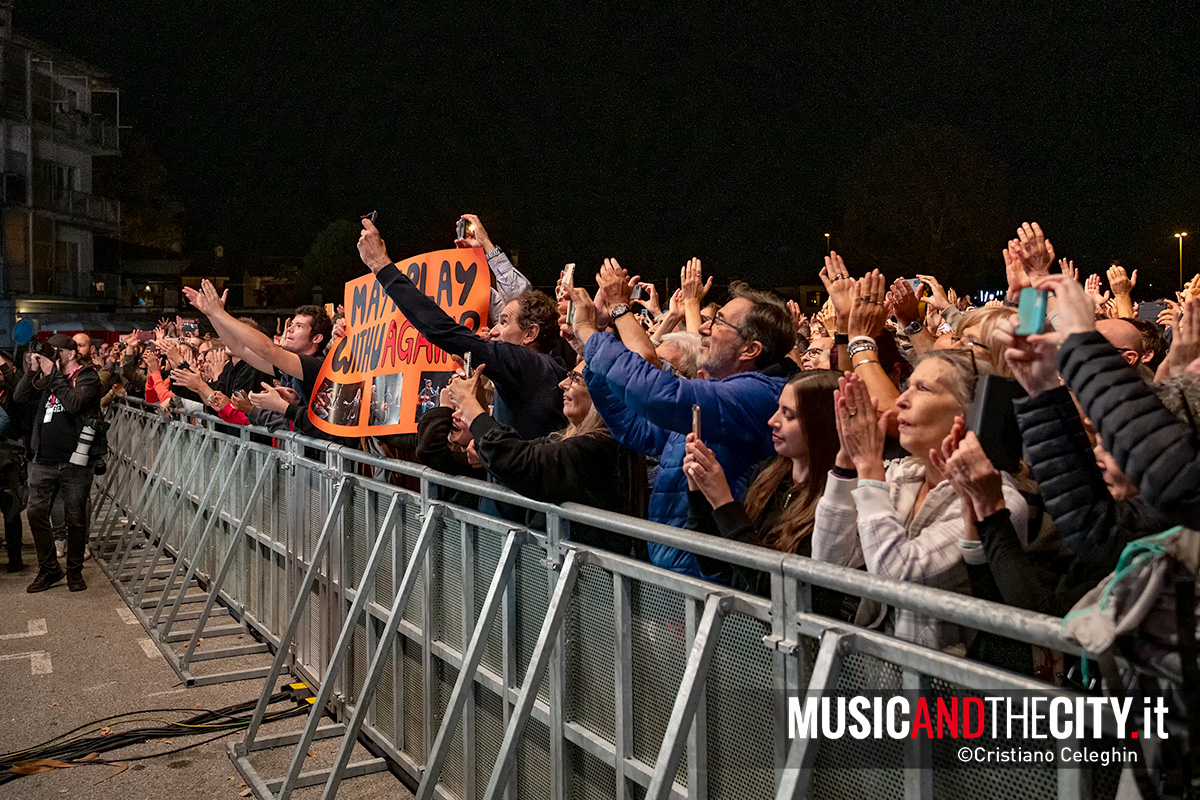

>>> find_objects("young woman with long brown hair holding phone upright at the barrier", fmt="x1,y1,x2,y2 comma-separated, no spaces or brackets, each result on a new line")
683,369,841,615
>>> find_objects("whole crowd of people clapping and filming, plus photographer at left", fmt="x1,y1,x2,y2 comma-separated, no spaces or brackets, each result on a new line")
0,215,1200,678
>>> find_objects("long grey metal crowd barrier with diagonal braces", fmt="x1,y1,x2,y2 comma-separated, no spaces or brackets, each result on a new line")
91,403,1116,800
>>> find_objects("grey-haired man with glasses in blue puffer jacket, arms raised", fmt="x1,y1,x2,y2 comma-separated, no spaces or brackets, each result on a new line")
575,283,796,579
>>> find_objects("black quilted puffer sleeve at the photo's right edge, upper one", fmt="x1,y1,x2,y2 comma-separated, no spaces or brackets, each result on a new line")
1058,331,1200,528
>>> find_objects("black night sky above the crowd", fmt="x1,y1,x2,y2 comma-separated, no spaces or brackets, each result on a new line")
16,0,1200,294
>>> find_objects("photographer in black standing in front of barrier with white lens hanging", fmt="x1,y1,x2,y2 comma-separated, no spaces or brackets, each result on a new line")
14,333,101,593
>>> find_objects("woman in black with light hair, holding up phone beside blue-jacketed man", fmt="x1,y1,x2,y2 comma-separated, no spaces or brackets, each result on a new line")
449,361,647,554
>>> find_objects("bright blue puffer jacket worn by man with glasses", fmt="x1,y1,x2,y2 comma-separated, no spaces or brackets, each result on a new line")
583,333,787,581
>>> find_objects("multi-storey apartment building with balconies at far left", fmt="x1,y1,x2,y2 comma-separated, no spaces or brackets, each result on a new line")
0,0,121,345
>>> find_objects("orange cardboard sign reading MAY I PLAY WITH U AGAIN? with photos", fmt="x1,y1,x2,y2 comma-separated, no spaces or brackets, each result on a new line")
308,247,492,437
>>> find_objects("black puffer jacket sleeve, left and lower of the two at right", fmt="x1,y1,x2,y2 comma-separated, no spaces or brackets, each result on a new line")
1013,383,1161,575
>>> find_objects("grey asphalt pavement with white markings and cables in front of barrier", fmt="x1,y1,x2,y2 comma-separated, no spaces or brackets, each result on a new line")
0,515,412,800
